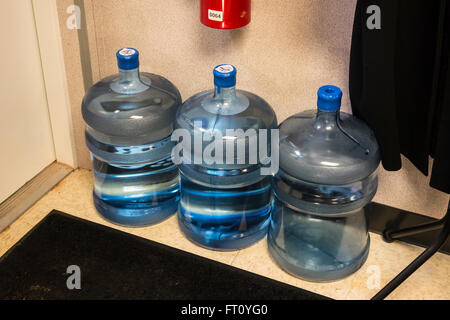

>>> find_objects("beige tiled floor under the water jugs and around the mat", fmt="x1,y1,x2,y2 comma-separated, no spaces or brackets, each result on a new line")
0,170,450,299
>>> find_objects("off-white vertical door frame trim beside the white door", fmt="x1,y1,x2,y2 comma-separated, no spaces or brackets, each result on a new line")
32,0,77,168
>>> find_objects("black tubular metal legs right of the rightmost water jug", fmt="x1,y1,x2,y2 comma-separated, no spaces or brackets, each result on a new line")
372,201,450,300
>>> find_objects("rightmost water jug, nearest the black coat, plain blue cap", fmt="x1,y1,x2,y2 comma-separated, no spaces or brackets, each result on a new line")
268,86,380,282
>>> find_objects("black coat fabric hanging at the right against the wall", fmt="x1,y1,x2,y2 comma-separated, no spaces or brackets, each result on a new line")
350,0,450,193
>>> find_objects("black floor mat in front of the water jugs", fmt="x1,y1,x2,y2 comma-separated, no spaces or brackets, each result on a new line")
0,211,325,300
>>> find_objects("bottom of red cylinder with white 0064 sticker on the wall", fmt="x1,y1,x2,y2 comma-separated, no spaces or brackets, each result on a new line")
200,0,251,29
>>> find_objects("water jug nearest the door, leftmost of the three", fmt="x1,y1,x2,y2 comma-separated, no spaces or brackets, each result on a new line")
82,48,182,227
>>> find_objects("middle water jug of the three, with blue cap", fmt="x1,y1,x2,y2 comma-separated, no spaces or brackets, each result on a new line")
176,65,277,250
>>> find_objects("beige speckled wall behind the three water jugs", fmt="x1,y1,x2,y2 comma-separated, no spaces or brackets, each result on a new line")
58,0,448,217
